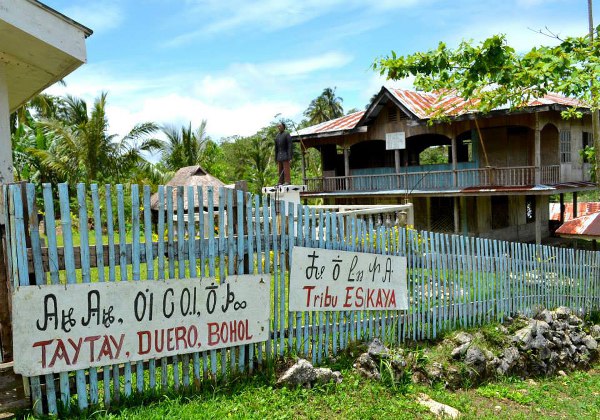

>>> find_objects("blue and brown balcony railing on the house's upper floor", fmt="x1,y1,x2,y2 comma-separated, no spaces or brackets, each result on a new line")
305,165,560,193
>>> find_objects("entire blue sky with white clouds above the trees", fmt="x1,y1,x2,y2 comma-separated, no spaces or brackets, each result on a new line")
42,0,600,140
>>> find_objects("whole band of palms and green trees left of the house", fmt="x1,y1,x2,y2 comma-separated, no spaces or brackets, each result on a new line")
11,88,343,193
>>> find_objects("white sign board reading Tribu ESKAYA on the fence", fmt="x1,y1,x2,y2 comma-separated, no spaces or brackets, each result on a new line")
289,246,408,311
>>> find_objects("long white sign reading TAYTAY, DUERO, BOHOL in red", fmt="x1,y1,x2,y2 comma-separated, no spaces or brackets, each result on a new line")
13,275,271,376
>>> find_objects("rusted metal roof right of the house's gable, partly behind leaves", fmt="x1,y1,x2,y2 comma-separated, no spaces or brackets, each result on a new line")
387,89,586,119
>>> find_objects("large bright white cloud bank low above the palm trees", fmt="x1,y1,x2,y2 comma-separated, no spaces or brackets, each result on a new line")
43,52,352,139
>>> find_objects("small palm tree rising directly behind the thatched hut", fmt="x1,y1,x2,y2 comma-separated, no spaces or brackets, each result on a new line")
159,120,209,170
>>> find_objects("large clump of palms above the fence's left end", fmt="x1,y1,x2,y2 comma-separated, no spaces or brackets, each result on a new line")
12,93,158,184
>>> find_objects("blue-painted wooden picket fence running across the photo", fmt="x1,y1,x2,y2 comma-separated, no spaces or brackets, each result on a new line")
2,184,600,414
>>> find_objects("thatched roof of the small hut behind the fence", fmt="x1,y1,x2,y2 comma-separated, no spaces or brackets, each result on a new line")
150,165,225,210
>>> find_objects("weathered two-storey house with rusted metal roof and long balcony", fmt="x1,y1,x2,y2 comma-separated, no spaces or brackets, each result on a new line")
292,87,595,243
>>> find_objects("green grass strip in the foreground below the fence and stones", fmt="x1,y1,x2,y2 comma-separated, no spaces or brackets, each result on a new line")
16,347,600,420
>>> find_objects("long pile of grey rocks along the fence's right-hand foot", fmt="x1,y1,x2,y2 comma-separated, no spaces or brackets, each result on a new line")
354,307,600,389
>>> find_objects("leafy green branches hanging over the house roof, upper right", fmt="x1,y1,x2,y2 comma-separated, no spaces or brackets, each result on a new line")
373,27,600,179
